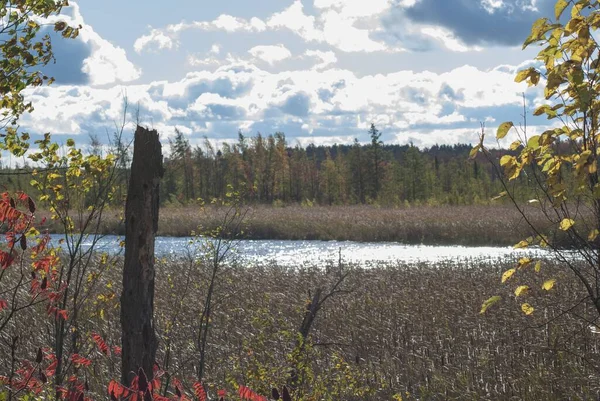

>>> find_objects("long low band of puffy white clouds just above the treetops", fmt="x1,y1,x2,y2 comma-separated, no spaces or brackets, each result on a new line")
22,53,546,149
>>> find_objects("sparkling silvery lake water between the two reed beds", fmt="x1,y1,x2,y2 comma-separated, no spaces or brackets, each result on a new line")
51,234,548,266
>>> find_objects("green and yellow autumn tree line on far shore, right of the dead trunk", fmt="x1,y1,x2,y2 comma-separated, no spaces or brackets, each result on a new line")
161,124,501,206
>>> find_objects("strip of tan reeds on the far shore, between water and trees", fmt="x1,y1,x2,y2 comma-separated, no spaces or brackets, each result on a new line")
43,205,548,246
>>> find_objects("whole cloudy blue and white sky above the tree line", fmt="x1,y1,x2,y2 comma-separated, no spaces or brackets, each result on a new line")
20,0,554,147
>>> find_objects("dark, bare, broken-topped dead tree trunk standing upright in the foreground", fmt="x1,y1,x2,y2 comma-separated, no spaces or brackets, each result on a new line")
121,126,164,386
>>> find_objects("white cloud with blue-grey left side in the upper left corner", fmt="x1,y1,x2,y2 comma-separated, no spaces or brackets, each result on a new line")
41,2,141,85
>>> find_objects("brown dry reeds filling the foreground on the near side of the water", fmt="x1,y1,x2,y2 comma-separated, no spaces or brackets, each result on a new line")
0,253,600,401
